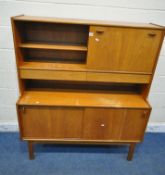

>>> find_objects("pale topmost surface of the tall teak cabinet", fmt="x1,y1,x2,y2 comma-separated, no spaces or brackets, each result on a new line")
12,15,164,29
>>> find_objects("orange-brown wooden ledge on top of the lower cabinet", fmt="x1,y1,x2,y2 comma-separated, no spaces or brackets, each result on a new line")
18,91,150,108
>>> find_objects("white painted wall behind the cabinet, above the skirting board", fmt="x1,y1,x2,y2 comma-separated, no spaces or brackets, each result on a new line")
0,0,165,123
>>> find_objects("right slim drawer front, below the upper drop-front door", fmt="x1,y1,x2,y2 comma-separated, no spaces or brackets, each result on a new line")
87,72,151,83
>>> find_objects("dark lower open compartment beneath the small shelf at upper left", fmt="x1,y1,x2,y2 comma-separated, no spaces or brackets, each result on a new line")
21,46,87,64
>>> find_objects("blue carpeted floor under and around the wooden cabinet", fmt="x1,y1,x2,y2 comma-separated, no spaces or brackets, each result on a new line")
0,133,165,175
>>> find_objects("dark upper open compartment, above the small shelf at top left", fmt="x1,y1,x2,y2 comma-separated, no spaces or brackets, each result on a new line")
16,21,89,46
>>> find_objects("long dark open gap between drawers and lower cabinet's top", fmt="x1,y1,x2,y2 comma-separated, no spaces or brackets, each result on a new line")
24,79,145,94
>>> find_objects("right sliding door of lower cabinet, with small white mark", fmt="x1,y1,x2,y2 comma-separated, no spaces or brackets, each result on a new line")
83,108,149,142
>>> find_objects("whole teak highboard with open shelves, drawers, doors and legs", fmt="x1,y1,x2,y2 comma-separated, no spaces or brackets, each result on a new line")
11,15,164,160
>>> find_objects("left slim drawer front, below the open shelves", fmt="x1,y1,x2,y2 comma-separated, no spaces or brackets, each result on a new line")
20,69,86,81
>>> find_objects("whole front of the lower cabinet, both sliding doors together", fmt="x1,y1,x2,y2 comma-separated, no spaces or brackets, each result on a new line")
19,107,150,142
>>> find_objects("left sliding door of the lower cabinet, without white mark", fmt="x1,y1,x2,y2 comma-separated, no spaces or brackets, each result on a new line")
20,107,83,139
